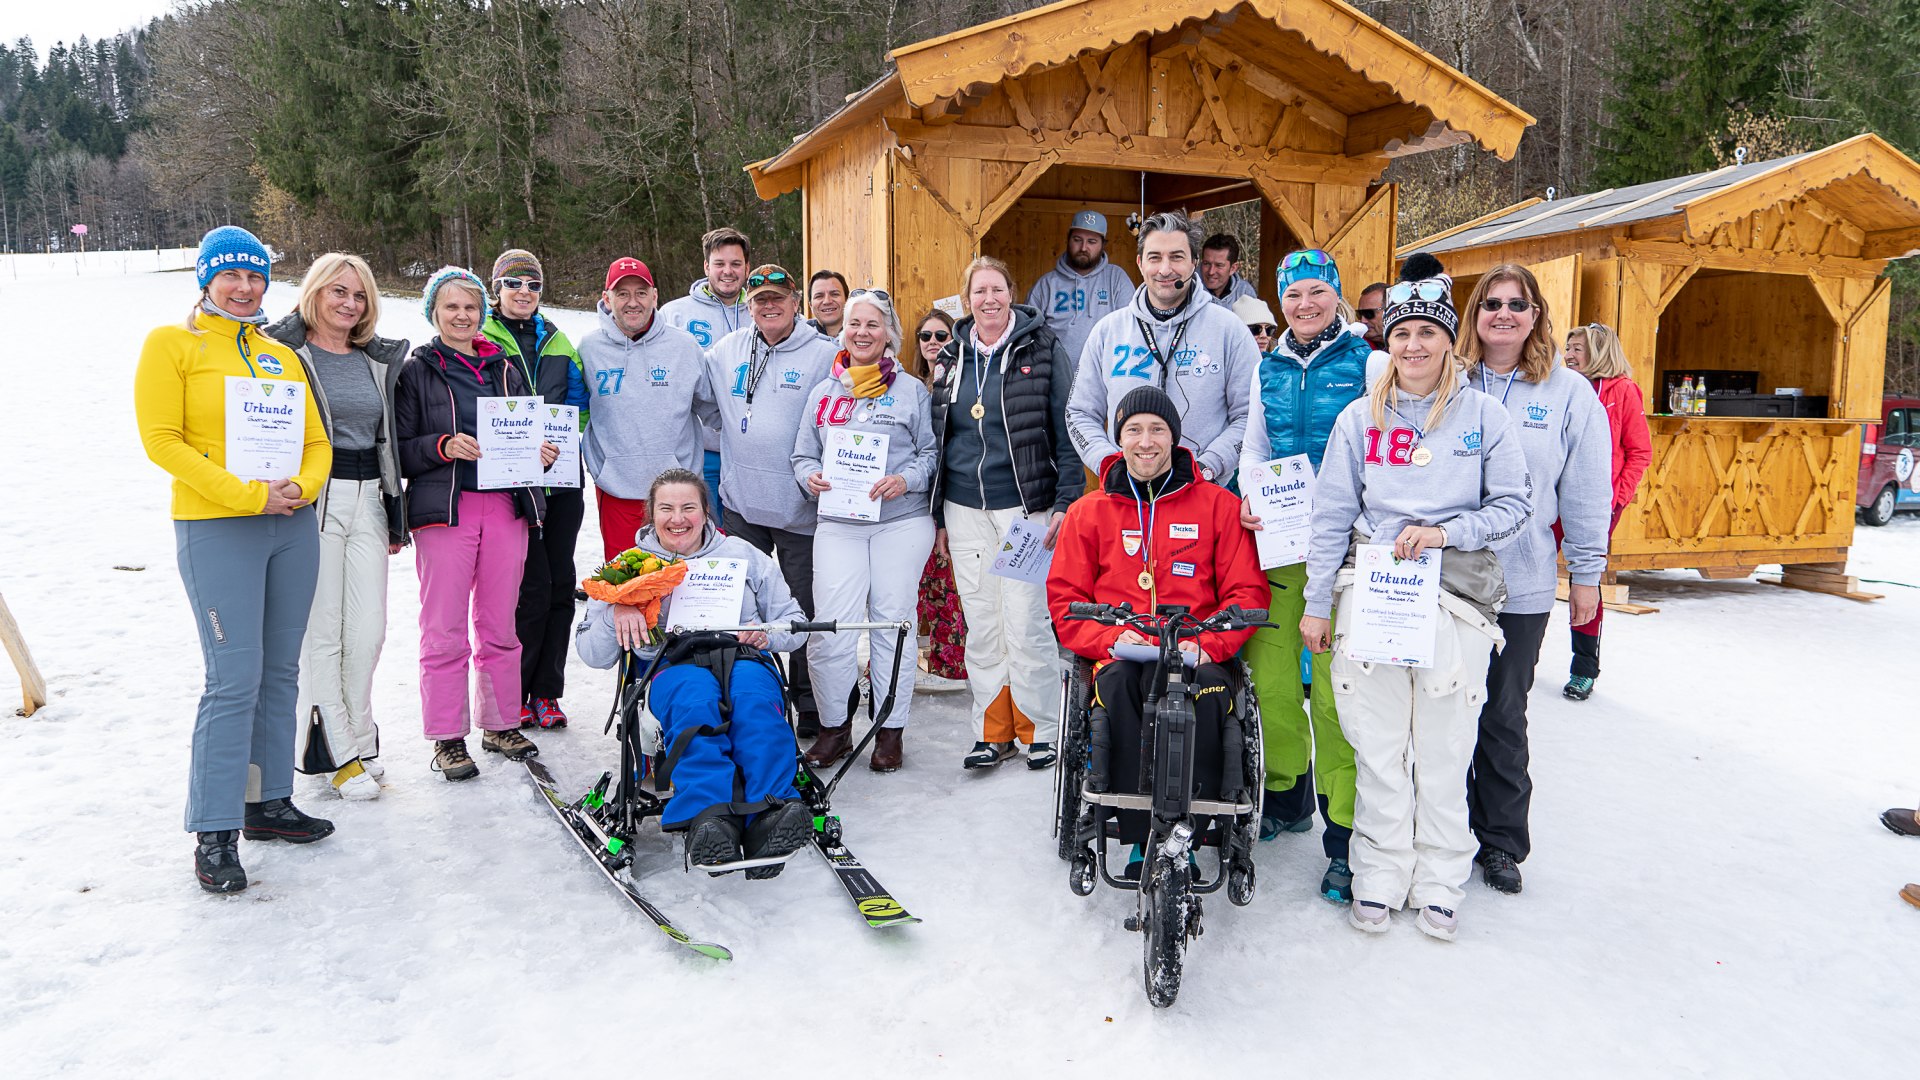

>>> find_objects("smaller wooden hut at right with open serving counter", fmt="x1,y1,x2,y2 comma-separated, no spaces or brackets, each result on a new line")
1400,135,1920,596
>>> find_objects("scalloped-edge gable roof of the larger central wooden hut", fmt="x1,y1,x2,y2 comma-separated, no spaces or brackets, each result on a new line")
747,0,1534,198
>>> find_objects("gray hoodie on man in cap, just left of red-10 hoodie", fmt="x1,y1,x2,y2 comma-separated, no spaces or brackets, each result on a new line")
707,321,839,536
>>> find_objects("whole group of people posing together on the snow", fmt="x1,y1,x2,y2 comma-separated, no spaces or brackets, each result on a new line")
136,211,1647,938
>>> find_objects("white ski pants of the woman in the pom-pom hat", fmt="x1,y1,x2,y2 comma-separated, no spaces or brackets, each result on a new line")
1332,590,1500,911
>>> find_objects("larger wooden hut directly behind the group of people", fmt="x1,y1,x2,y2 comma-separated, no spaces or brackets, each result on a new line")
747,0,1532,365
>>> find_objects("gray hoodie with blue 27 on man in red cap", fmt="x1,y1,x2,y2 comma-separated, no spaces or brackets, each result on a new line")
578,304,718,500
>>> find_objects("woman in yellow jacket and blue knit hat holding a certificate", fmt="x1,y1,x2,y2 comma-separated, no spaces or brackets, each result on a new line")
134,225,334,892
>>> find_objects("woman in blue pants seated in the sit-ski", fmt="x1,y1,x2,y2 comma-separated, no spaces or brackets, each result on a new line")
574,469,812,878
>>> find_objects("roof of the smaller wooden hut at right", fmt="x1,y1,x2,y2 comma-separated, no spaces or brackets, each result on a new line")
1400,133,1920,259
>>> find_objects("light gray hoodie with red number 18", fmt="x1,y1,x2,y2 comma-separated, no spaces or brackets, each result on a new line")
1306,376,1532,619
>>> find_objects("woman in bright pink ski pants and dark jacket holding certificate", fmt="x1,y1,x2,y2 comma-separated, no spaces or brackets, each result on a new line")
394,267,559,780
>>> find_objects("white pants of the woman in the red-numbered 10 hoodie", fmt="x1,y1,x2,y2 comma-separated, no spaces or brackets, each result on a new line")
806,515,933,728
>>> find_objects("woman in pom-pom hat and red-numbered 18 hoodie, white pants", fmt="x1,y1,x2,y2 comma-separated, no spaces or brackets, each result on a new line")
1300,254,1532,942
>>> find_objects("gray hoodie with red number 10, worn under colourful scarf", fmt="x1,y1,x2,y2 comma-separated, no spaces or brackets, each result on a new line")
793,367,941,525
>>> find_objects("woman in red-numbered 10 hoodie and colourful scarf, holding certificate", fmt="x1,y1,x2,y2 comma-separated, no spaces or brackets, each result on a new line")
793,288,939,773
